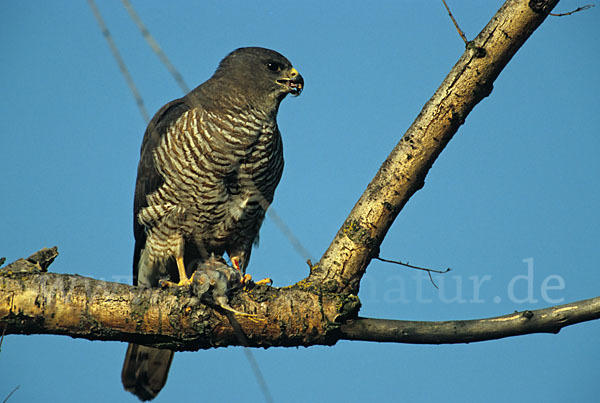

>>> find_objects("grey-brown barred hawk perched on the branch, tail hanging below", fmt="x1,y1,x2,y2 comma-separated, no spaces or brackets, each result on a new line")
122,47,304,401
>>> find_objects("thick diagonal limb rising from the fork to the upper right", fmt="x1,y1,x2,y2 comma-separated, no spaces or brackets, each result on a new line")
309,0,558,294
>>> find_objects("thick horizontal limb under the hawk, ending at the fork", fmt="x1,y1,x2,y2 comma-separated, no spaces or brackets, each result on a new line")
0,260,360,350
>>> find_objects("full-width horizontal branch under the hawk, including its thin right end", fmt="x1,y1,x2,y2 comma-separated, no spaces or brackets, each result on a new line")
0,256,600,351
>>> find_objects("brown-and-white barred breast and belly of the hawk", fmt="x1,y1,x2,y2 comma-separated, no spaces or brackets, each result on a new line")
138,102,283,269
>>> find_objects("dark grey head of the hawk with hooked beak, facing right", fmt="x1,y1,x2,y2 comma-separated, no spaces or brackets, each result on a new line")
212,47,304,108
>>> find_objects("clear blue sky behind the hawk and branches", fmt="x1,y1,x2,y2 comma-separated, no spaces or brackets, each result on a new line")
0,0,600,403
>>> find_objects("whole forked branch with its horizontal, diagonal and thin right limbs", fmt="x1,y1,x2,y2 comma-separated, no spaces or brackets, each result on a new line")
0,0,600,350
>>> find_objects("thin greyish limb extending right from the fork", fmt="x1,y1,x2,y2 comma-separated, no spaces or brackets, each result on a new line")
340,297,600,344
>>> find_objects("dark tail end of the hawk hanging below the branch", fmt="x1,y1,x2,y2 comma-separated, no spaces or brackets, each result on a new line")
121,344,174,401
